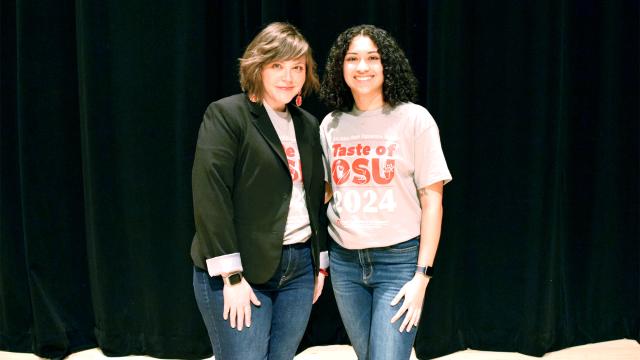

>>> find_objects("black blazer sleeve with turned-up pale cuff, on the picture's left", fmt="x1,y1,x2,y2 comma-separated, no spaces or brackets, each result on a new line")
192,103,242,276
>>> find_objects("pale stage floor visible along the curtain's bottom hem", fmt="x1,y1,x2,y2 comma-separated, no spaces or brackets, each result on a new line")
0,339,640,360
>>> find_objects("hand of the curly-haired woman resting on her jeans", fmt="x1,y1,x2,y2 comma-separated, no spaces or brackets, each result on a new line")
391,274,429,332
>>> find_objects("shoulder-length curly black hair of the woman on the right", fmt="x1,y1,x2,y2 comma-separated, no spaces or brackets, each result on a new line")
320,25,418,111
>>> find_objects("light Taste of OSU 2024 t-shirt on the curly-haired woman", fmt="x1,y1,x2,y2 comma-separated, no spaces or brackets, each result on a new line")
320,103,452,249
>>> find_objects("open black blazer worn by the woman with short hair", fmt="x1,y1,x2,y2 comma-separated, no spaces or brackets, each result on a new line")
191,94,326,284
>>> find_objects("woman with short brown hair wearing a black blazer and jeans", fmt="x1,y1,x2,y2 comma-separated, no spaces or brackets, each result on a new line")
191,23,328,360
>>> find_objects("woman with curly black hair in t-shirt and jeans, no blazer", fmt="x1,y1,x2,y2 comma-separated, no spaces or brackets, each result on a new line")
320,25,451,359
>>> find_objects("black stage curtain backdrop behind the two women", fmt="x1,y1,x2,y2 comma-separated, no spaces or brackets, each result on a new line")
0,0,640,358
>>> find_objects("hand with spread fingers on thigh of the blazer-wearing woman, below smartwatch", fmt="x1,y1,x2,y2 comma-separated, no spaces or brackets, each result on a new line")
222,278,260,331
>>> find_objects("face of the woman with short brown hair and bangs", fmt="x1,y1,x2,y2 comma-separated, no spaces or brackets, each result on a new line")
261,56,306,111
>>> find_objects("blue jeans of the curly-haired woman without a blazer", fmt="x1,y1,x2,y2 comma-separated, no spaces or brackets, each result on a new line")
329,238,420,360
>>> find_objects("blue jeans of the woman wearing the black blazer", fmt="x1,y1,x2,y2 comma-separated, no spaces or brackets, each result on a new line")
193,243,314,360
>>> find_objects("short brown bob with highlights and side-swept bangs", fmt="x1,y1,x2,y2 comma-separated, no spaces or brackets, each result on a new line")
238,22,320,101
